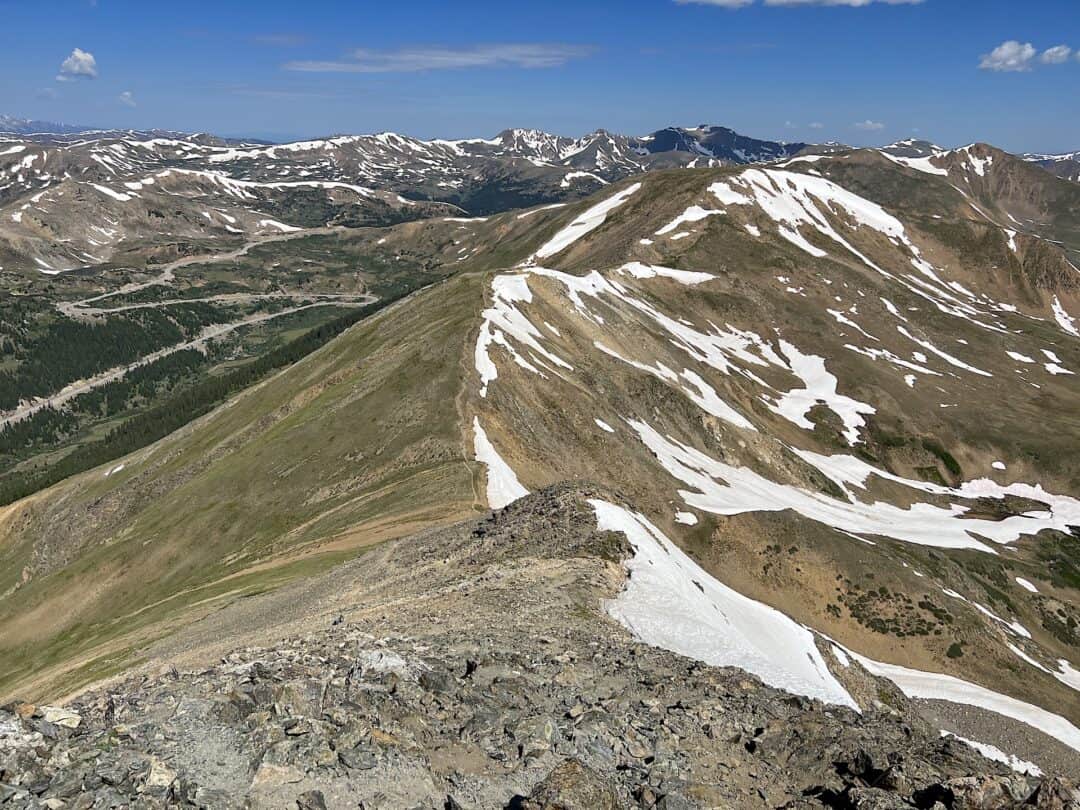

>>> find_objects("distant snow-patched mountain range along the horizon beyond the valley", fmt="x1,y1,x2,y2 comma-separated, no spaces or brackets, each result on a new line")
0,118,1065,273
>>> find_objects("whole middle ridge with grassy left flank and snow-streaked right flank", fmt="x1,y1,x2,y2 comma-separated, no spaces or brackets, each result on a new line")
0,147,1080,753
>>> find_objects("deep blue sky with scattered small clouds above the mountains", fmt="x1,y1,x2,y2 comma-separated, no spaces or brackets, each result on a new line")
0,0,1080,151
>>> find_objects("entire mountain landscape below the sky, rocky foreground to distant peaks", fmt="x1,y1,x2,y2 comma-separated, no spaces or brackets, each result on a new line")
0,114,1080,808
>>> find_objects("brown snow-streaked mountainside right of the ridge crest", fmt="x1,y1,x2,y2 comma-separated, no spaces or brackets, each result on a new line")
472,153,1080,734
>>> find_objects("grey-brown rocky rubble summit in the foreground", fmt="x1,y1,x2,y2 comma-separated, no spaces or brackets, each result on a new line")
0,486,1080,810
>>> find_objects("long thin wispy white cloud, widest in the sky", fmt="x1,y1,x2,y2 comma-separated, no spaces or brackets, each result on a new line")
285,43,593,73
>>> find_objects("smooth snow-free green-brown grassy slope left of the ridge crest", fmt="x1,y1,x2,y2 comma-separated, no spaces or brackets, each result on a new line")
0,278,481,693
